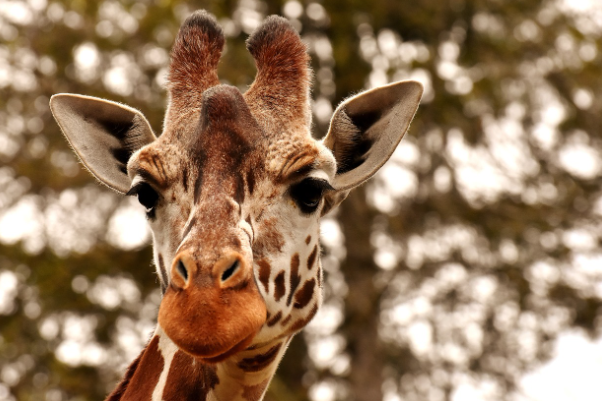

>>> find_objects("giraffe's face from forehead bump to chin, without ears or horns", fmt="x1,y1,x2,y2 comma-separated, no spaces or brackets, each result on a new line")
127,86,336,360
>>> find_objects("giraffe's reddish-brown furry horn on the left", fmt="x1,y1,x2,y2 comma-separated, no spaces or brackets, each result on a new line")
167,10,224,120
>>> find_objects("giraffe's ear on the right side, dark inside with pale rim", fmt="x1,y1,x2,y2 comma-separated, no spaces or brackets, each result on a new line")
323,81,423,213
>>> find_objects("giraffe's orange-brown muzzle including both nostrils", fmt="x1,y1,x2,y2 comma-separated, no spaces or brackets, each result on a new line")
159,251,267,362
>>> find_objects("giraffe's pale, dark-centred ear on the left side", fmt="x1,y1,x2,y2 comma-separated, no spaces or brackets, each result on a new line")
50,93,156,194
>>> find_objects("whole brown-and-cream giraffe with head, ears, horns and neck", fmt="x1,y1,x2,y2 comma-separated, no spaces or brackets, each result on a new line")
50,11,423,401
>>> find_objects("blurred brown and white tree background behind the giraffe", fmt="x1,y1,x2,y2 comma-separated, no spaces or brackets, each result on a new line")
0,0,602,401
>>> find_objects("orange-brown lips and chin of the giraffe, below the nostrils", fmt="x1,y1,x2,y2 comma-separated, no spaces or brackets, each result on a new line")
158,285,267,363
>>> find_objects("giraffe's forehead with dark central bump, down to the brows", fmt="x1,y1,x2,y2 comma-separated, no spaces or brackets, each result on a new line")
129,85,334,186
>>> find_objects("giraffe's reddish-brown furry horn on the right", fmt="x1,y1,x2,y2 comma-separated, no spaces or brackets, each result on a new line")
244,15,311,133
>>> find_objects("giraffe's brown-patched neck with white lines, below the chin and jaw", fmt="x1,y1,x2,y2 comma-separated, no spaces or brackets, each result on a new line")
105,326,291,401
